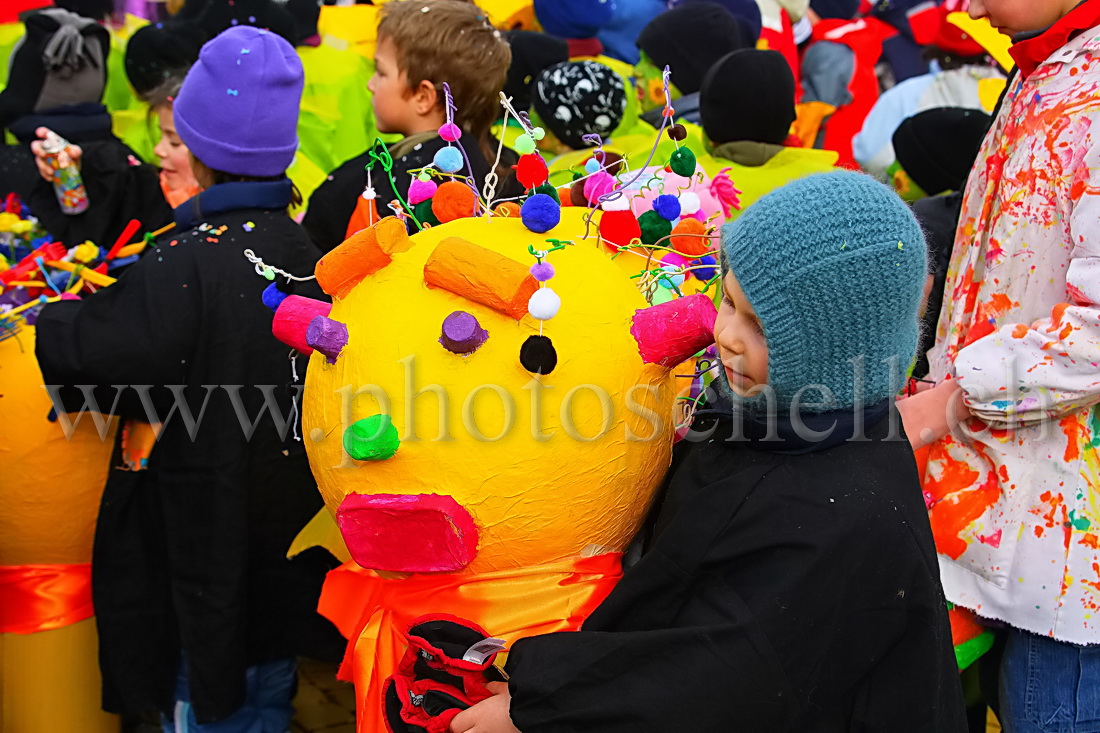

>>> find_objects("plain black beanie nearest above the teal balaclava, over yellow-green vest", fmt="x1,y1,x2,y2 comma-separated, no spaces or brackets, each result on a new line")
699,48,794,145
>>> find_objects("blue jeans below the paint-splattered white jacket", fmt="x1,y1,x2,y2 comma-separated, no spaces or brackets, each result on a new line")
1000,628,1100,733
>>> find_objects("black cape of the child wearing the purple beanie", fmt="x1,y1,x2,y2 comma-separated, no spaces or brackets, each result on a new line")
36,182,339,722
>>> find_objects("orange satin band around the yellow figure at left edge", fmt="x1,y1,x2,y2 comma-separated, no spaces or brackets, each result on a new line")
0,562,95,634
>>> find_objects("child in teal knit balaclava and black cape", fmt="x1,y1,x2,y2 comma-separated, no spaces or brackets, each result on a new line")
451,172,966,733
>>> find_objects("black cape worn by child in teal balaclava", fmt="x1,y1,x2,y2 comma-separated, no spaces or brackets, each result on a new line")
506,402,966,733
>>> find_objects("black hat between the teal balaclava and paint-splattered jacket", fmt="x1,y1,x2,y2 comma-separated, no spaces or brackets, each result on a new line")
893,107,991,196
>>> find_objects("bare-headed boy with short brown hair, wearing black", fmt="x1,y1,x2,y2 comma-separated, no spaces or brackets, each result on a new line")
303,0,512,252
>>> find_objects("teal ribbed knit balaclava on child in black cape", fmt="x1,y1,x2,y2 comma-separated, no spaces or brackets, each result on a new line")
722,172,927,414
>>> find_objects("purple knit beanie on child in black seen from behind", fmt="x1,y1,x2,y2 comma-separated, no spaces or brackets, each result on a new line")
173,25,303,176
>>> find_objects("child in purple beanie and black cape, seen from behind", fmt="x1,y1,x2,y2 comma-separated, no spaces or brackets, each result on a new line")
36,26,336,731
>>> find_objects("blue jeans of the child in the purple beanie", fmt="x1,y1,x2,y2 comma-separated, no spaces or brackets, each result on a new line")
161,659,298,733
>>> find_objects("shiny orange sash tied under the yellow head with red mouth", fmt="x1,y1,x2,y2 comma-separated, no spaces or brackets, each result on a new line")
318,553,623,733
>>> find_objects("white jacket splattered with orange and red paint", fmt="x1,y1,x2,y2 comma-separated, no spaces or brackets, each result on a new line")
924,26,1100,644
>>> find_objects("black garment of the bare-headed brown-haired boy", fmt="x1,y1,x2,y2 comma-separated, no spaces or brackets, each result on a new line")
301,135,523,253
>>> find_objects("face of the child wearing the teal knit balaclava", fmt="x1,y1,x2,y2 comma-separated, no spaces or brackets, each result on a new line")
714,272,768,396
